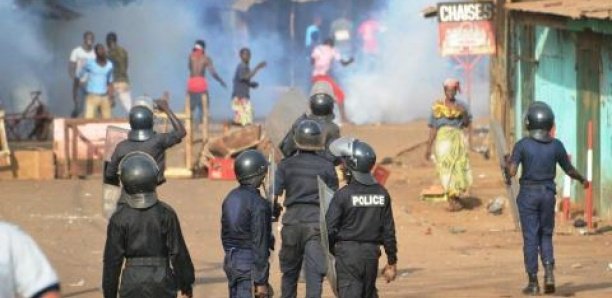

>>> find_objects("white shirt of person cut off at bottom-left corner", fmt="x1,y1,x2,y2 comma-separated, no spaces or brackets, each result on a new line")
0,221,59,298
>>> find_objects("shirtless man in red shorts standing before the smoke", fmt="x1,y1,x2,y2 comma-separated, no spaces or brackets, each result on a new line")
187,40,227,142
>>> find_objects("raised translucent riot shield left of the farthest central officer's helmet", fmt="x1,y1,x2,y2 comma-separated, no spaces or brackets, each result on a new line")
264,89,308,147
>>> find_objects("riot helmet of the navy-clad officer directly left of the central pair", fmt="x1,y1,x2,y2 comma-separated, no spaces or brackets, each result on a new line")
234,150,268,188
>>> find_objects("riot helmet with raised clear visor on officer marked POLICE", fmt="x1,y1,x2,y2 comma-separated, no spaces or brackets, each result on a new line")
329,137,377,185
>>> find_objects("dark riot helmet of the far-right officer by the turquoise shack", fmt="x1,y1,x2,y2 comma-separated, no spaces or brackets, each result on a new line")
525,101,555,143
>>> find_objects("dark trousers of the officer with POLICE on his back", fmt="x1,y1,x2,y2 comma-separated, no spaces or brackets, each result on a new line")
334,241,380,298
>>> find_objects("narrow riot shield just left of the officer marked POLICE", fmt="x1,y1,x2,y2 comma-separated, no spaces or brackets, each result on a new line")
317,176,338,297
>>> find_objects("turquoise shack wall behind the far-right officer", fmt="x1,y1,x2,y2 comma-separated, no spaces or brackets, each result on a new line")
509,22,612,218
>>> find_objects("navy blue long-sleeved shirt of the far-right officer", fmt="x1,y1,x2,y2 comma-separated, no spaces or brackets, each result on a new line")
512,137,572,187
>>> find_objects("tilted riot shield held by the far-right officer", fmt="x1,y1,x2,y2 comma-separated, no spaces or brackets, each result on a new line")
491,121,521,231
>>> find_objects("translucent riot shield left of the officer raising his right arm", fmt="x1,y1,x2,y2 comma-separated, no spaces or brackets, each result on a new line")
102,126,129,219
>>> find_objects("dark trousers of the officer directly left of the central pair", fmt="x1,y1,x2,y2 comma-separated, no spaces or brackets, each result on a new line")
223,249,253,298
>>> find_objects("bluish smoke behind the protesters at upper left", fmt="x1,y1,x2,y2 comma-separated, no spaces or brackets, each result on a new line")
0,0,279,118
